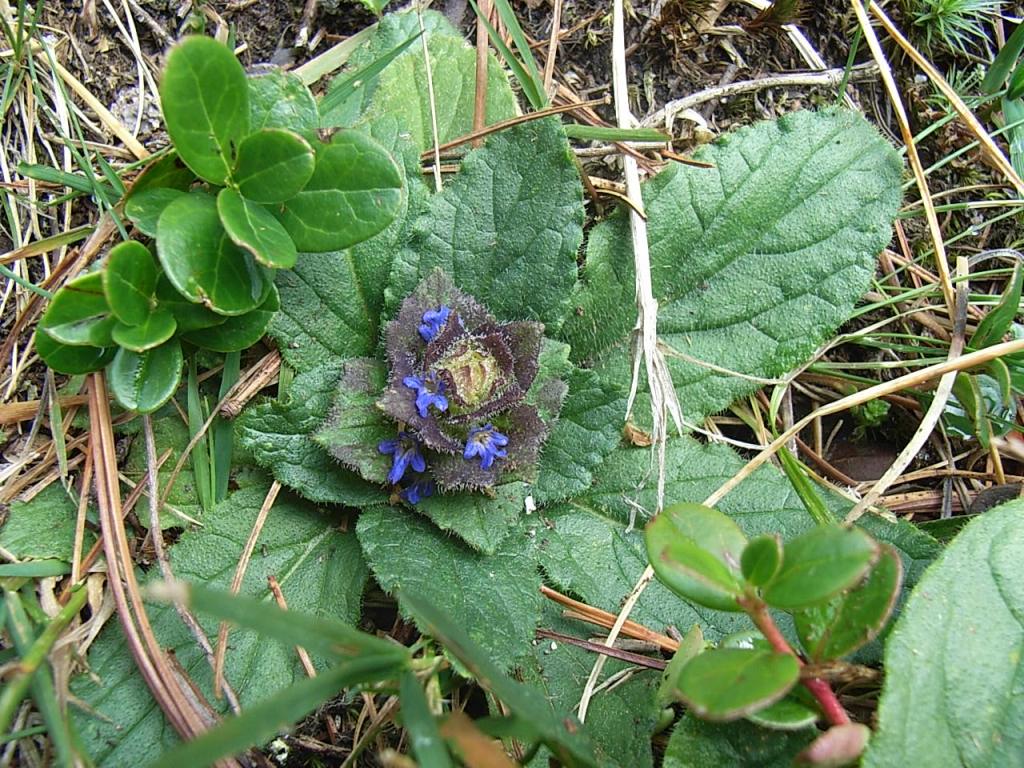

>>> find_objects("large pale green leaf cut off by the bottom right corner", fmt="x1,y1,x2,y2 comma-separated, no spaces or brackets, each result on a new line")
863,502,1024,768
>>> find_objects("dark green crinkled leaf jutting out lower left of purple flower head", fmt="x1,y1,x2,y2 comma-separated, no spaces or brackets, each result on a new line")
237,366,382,507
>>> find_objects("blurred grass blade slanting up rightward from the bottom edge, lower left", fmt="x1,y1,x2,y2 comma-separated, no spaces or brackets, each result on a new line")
152,656,401,768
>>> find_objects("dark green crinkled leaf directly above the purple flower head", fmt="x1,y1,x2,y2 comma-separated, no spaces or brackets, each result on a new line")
389,119,583,336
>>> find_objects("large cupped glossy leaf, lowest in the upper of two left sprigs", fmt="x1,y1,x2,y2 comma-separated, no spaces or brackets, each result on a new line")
157,193,273,315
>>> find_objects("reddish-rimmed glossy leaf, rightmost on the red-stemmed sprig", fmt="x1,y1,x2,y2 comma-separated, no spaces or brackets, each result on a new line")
793,545,903,662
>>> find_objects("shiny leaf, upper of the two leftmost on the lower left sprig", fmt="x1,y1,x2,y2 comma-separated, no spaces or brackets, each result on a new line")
39,272,117,347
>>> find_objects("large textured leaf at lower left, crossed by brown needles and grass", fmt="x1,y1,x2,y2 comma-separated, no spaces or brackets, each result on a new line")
71,482,367,766
